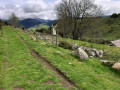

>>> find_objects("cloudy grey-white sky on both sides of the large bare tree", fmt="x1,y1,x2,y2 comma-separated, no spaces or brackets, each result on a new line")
0,0,120,20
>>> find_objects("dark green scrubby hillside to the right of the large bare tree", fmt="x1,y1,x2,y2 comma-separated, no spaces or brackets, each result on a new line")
84,17,120,43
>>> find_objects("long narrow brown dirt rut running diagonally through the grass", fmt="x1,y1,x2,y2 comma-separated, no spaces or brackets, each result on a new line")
16,32,80,90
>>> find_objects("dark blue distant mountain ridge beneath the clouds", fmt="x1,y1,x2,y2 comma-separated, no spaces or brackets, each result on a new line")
20,18,56,29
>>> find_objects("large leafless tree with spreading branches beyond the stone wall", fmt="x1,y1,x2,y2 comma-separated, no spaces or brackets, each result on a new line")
57,0,102,39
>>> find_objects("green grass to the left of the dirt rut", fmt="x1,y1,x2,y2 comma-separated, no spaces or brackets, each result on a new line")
0,27,63,90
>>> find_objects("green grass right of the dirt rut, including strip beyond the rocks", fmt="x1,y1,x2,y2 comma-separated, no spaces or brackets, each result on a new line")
16,25,120,90
